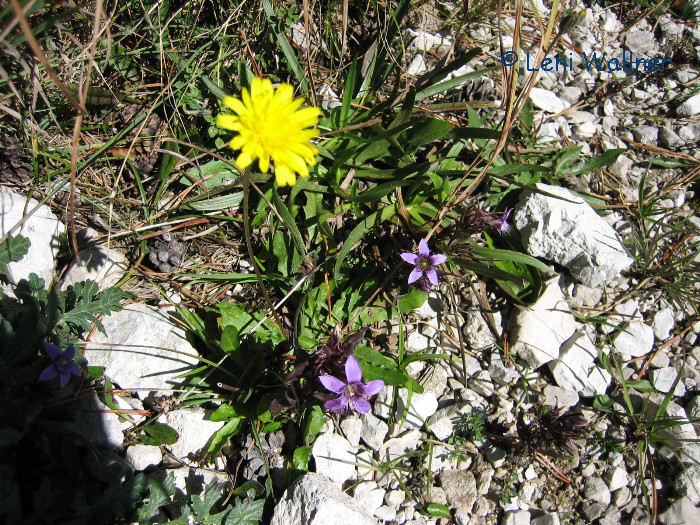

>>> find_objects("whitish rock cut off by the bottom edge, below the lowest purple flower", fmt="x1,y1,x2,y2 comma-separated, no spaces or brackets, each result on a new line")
270,472,377,525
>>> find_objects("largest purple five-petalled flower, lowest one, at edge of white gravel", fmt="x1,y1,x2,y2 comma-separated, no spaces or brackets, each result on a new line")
318,355,384,414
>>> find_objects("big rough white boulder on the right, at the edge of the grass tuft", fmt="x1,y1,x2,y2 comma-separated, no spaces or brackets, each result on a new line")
514,183,633,287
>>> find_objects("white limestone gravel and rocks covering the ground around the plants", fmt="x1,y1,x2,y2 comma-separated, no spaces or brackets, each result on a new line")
2,1,700,525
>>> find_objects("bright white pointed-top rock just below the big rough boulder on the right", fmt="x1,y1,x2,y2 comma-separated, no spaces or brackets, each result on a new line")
511,279,576,369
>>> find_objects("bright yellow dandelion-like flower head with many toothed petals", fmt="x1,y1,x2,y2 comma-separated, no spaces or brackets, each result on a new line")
216,77,321,186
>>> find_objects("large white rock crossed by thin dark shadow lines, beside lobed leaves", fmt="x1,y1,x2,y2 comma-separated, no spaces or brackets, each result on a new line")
85,304,198,399
